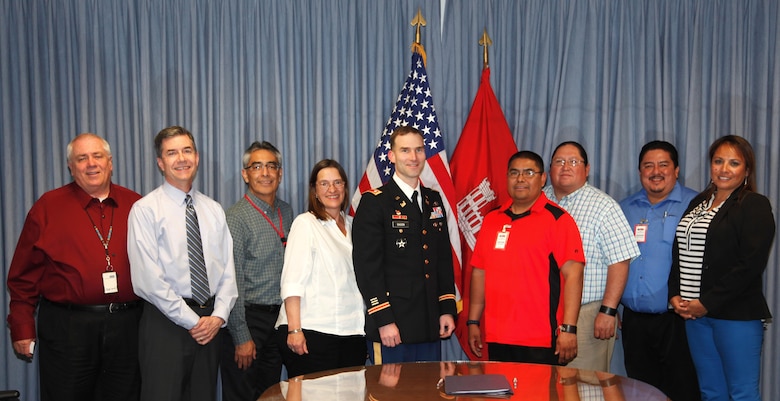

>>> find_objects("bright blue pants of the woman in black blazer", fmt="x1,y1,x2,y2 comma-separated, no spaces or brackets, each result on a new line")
685,317,764,401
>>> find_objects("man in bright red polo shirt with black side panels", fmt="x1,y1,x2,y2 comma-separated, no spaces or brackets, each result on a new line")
467,151,585,365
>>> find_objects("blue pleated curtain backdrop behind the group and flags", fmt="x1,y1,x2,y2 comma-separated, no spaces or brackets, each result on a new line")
0,0,780,400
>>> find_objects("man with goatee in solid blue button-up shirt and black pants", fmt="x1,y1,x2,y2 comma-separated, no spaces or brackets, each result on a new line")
620,141,700,400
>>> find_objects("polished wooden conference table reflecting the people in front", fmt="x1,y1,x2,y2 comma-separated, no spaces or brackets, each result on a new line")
258,362,668,401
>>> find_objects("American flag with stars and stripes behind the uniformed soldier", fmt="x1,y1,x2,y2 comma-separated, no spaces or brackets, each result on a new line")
351,44,461,300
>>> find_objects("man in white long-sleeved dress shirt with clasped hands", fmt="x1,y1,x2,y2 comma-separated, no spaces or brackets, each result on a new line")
127,126,238,400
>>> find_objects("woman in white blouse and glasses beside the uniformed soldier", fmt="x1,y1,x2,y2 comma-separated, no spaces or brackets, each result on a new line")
276,159,366,377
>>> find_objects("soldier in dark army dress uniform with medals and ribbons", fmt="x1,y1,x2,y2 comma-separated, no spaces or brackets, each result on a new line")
352,127,456,364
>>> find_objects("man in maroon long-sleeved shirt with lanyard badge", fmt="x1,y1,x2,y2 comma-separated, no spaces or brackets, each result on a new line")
8,134,143,401
